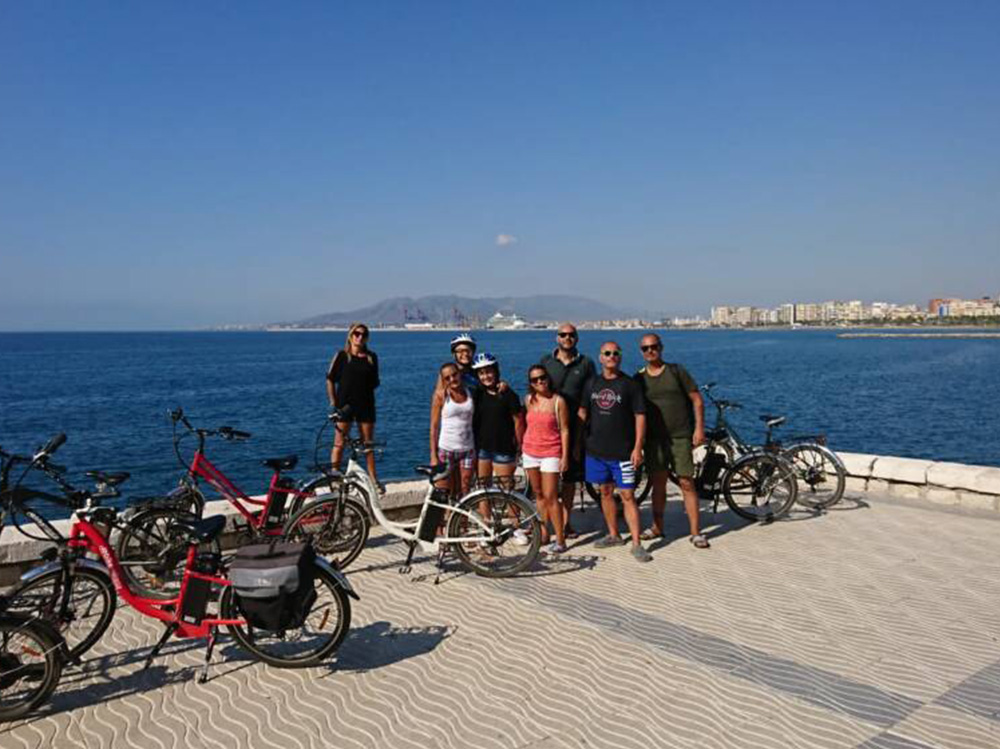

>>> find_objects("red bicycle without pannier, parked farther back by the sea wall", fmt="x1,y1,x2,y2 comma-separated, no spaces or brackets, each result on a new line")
116,408,369,598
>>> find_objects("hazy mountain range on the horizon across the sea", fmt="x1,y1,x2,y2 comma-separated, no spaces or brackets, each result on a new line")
275,294,645,328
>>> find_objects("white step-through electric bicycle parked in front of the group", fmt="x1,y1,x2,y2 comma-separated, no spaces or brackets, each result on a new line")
285,411,542,582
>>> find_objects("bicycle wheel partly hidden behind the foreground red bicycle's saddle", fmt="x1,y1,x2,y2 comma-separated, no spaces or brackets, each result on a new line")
115,507,222,600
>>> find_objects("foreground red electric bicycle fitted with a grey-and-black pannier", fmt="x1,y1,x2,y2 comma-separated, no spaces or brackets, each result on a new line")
3,435,358,681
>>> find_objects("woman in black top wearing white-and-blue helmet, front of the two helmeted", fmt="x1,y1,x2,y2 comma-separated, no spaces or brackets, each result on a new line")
472,353,524,486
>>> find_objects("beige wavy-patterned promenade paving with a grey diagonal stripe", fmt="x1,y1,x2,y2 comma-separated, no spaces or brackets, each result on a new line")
0,490,1000,749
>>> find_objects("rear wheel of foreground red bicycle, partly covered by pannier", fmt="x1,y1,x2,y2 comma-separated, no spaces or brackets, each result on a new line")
220,565,351,668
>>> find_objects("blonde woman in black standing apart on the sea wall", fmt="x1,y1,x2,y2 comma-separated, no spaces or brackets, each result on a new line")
326,323,381,487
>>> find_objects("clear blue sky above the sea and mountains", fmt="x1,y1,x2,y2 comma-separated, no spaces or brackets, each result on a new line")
0,0,1000,330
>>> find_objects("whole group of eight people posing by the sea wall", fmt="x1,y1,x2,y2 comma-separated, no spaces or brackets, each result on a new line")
327,323,709,562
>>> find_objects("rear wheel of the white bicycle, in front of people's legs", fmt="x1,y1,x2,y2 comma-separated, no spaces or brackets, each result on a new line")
447,489,542,577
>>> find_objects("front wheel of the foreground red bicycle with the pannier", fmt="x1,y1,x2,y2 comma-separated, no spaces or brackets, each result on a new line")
3,566,118,658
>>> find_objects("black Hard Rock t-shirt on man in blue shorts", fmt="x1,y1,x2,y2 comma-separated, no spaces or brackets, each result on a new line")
581,374,646,460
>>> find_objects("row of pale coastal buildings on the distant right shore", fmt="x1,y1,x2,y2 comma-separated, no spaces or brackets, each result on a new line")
711,297,1000,327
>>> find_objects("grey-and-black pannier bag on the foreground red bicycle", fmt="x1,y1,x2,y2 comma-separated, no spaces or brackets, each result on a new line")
229,542,316,632
